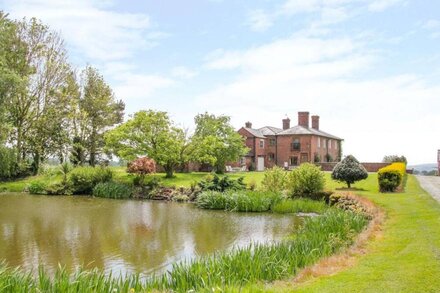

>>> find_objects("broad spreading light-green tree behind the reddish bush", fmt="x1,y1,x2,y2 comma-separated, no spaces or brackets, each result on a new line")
105,110,189,178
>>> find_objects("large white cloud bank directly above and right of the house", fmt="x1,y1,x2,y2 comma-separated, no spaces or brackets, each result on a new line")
197,36,440,163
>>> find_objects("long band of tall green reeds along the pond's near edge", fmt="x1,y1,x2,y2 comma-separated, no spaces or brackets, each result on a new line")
0,208,368,292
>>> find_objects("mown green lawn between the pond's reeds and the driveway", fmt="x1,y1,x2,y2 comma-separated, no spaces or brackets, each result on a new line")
254,174,440,292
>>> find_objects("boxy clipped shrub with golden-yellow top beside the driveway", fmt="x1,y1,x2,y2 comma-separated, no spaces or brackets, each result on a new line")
377,163,406,192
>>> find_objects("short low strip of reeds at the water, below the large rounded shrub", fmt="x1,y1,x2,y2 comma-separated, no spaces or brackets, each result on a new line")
271,198,328,214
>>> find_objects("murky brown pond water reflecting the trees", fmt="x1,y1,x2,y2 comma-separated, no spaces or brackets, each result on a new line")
0,194,301,276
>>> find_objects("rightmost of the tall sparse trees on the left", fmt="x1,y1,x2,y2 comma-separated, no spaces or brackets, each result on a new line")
76,66,125,166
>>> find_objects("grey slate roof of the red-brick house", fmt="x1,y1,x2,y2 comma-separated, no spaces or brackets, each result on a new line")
244,125,343,140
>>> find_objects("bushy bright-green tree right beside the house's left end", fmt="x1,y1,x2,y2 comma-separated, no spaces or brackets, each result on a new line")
192,112,249,173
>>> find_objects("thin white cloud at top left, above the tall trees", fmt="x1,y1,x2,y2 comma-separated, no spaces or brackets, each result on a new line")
4,0,166,63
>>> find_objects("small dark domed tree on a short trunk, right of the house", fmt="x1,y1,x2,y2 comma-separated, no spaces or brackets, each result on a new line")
332,155,368,188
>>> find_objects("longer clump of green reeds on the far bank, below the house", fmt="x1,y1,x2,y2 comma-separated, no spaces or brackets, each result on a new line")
196,190,281,212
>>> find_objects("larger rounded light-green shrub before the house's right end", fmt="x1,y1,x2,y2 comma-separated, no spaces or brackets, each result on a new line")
287,163,325,197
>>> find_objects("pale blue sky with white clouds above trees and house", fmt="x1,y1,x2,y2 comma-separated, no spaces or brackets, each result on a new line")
0,0,440,164
